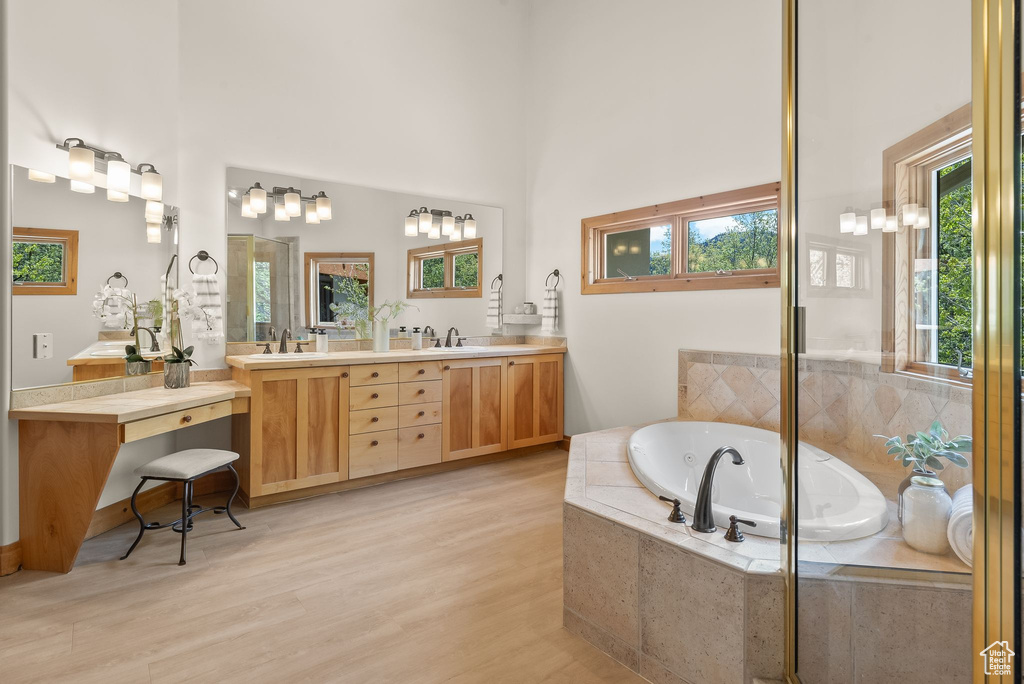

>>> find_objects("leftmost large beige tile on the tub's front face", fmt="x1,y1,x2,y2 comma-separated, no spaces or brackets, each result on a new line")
562,505,640,648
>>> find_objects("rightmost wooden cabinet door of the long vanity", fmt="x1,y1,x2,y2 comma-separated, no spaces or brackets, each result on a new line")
508,354,564,448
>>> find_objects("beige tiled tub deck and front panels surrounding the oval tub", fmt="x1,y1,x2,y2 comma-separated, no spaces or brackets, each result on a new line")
563,427,971,684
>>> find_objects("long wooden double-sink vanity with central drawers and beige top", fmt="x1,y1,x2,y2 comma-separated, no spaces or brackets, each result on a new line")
226,345,565,507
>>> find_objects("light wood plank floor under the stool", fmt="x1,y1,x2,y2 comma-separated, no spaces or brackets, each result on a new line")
0,452,643,684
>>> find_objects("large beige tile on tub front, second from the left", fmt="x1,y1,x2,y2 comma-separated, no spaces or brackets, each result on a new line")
640,536,743,684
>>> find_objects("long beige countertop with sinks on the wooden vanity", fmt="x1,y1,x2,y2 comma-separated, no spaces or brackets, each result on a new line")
224,344,567,371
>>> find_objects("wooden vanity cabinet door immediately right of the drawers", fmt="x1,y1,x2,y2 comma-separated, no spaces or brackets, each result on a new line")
441,358,508,461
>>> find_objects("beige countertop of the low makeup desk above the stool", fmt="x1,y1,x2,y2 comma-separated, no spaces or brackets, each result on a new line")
7,380,251,423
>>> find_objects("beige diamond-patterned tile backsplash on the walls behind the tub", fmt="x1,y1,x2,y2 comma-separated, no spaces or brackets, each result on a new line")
678,349,972,499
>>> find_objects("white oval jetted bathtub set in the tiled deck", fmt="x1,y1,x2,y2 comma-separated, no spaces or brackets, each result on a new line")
629,421,889,542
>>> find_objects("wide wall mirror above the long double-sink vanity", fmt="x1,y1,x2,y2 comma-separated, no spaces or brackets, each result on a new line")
225,168,503,342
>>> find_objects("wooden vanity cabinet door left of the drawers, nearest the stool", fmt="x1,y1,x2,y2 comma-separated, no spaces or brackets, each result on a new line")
248,367,349,497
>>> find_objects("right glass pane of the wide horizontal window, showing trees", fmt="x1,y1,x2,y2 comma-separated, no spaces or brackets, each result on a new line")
687,209,778,273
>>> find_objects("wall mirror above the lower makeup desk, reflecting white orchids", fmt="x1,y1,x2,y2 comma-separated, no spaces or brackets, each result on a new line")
11,166,178,389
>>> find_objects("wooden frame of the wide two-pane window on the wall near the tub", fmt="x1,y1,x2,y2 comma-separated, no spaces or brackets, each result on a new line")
580,182,781,295
